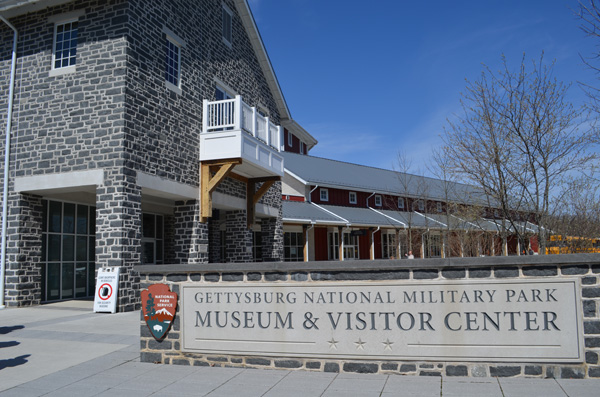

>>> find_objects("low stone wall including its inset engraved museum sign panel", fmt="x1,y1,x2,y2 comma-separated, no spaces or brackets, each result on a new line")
138,254,600,378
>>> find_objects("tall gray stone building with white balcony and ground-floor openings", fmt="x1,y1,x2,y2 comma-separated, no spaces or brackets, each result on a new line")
0,0,316,310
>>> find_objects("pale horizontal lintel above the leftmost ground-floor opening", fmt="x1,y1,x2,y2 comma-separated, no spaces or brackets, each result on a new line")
15,169,104,192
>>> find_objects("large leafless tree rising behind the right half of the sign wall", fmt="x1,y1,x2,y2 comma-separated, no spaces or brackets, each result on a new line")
442,54,595,255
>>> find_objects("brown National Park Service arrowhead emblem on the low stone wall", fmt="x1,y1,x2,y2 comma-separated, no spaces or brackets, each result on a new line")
142,284,177,341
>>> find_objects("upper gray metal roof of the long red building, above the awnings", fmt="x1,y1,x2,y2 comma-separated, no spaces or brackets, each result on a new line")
283,152,488,205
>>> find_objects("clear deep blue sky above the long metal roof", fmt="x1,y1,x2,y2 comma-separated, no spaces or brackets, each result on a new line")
249,0,600,174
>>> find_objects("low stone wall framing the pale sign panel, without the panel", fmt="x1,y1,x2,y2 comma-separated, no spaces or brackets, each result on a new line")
137,254,600,378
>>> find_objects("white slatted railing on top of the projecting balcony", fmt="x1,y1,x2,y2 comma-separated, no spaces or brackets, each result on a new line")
202,95,282,152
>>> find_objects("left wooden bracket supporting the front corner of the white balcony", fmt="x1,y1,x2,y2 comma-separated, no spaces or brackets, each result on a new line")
200,159,242,223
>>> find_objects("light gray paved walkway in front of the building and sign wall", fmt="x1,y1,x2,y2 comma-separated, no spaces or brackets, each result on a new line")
0,301,600,397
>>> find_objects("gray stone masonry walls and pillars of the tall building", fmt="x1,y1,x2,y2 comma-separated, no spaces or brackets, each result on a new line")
0,0,281,311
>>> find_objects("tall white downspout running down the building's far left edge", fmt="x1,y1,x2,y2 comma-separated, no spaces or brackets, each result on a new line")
0,15,18,309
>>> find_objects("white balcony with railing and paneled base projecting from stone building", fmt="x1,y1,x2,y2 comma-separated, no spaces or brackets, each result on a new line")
200,95,283,178
